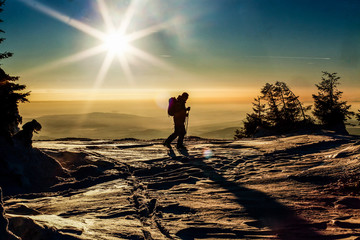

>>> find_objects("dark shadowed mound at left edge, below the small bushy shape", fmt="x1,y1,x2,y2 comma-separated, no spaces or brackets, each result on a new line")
0,137,69,195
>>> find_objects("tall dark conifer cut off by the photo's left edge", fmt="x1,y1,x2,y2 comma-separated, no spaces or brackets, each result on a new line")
0,0,30,137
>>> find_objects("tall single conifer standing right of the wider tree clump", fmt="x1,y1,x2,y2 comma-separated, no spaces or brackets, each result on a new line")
312,71,355,133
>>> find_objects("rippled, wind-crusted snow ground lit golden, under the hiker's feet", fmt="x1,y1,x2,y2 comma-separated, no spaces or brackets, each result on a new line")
5,134,360,240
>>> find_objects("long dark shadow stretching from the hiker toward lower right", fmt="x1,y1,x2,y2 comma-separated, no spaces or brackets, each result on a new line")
177,158,326,240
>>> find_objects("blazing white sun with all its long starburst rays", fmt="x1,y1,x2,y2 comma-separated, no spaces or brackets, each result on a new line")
19,0,175,89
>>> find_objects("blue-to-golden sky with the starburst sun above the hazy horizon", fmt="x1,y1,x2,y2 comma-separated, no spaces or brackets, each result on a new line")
0,0,360,101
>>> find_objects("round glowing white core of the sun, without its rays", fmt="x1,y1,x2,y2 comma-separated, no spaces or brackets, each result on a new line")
103,32,131,56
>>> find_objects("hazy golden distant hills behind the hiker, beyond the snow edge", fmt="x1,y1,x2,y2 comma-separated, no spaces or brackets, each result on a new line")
24,112,240,140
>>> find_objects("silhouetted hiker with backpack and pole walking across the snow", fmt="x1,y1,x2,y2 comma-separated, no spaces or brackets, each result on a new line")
164,92,190,149
